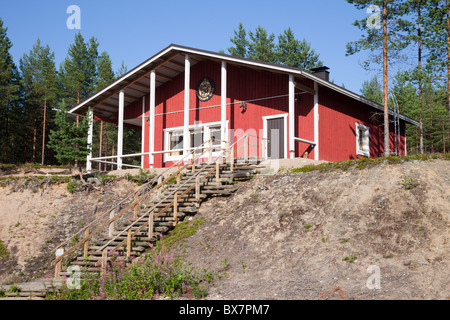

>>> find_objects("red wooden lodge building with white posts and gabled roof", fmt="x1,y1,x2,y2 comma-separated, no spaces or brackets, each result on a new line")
70,44,420,170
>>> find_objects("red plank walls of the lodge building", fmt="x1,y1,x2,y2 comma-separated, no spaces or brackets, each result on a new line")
121,61,405,167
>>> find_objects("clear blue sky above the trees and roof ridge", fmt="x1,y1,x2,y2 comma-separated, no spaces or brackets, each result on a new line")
0,0,400,93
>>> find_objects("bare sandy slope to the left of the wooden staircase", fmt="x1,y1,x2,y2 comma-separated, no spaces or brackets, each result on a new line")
0,175,138,284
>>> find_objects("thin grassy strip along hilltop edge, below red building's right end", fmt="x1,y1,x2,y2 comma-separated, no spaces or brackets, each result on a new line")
291,153,450,173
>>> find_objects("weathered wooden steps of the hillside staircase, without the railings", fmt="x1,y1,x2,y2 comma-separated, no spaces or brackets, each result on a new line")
59,164,254,276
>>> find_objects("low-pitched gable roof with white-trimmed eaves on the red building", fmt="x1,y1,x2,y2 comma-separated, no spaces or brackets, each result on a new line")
69,44,420,126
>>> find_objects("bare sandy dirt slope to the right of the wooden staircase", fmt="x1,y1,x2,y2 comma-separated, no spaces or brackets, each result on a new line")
170,160,450,299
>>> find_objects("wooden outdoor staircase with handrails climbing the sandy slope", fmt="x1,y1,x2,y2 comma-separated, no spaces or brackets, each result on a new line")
52,136,266,278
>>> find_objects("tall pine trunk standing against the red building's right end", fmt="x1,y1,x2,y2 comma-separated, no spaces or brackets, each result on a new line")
383,0,391,157
